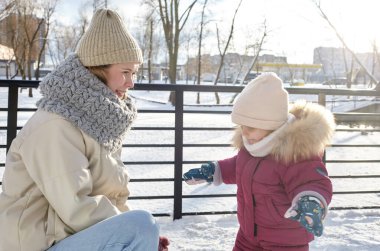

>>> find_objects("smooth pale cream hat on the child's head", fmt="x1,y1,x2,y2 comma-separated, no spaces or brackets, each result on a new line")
231,72,288,130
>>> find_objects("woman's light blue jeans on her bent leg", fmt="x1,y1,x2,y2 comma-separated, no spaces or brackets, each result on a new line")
48,210,159,251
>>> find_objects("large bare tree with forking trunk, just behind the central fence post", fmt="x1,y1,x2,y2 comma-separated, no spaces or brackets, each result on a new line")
157,0,198,105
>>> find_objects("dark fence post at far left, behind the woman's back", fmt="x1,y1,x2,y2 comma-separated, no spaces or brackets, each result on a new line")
7,83,18,152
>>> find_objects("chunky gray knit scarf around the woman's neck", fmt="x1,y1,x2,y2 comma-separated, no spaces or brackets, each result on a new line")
37,54,136,152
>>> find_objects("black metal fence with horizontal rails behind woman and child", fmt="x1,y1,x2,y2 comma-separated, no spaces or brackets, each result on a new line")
0,80,380,219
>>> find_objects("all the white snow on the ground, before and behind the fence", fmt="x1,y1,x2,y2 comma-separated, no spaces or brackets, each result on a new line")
0,83,380,251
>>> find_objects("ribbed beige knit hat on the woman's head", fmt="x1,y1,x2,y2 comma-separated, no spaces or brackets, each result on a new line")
76,9,143,66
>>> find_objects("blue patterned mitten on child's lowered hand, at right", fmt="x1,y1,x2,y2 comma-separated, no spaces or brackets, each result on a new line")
285,195,325,237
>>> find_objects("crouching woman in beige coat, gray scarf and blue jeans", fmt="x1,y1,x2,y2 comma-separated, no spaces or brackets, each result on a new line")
0,9,168,251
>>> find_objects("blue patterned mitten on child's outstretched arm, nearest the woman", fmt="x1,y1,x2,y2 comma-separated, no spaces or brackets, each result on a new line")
183,162,215,185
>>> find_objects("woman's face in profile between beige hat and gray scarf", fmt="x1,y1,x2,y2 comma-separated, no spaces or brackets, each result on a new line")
106,63,140,99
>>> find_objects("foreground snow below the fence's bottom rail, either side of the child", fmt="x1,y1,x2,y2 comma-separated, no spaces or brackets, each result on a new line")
159,210,380,251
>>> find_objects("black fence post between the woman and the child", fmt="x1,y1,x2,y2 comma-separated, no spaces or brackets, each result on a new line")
173,89,183,220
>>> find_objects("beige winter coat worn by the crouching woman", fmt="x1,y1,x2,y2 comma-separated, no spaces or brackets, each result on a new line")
0,111,129,251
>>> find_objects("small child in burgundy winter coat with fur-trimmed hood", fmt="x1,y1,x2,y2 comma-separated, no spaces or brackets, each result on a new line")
184,73,335,251
